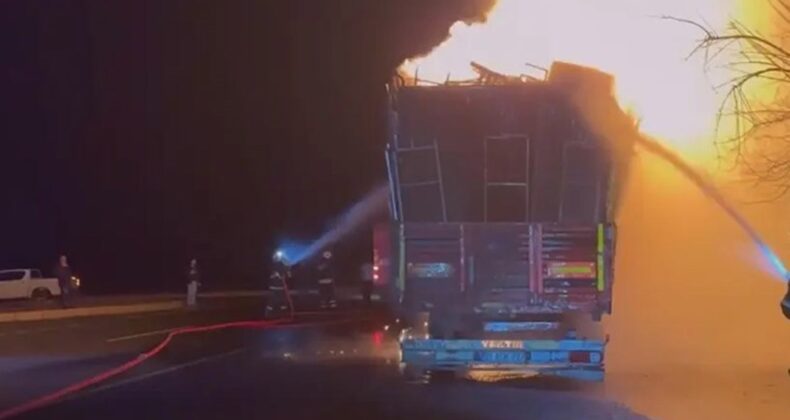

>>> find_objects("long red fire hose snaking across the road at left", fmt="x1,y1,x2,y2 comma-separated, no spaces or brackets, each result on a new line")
0,281,338,420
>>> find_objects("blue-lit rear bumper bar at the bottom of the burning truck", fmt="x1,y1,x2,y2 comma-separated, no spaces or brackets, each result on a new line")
400,338,606,382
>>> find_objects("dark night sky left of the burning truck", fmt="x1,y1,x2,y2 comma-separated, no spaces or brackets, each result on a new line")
0,0,493,291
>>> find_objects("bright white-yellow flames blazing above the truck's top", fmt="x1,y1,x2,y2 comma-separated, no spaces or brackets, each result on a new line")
403,0,739,156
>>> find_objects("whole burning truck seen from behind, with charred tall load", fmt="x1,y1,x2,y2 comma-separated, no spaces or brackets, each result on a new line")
374,63,635,380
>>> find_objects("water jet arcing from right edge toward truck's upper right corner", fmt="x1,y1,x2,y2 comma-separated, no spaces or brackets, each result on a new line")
636,137,790,281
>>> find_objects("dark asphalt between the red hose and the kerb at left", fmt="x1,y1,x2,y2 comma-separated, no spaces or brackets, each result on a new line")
0,298,262,411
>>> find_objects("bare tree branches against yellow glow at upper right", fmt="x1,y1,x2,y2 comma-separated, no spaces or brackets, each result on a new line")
672,12,790,200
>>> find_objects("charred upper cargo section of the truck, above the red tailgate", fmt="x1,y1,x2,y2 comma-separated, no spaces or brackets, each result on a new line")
388,64,616,225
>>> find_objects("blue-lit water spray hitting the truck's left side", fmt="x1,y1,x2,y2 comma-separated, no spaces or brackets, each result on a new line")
280,185,388,264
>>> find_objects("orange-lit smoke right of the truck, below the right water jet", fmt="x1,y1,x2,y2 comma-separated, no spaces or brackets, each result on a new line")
604,155,790,418
